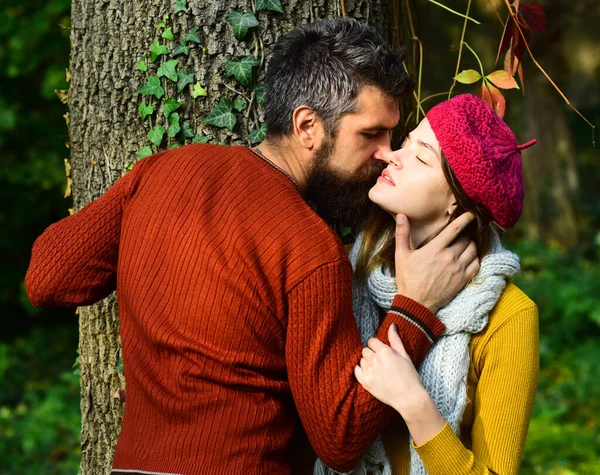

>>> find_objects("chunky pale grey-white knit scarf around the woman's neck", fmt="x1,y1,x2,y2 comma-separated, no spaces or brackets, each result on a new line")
314,232,520,475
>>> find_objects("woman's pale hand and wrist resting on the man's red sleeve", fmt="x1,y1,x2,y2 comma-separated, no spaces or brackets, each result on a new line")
354,325,446,445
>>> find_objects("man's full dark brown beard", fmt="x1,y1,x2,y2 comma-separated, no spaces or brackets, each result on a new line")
306,139,385,232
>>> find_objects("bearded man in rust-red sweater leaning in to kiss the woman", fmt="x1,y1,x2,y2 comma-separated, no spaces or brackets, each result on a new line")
26,19,477,474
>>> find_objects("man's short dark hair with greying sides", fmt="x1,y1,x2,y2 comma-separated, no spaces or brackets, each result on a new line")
265,17,413,140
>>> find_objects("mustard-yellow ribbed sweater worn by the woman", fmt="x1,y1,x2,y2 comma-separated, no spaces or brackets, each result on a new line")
293,283,539,475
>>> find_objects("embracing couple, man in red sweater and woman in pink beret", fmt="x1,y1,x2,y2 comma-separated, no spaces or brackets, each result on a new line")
26,19,539,475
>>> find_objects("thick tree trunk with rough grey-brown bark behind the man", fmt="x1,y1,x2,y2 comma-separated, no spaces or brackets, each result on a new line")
69,0,391,475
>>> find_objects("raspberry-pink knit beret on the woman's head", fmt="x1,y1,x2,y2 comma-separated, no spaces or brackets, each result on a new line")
427,94,536,228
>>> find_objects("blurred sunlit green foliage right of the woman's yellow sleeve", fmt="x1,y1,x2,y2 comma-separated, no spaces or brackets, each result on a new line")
515,242,600,475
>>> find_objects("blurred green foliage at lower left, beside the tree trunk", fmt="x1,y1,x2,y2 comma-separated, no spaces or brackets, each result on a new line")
0,328,81,475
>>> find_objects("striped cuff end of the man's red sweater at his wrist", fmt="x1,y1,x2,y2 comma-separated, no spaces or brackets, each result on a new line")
385,295,446,367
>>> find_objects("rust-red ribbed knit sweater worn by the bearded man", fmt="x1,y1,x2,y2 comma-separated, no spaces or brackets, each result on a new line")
26,145,444,474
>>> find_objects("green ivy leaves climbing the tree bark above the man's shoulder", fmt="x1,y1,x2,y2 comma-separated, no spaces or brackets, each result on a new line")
136,0,284,167
